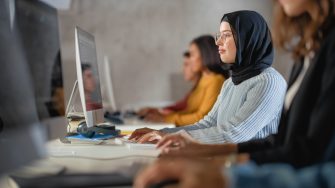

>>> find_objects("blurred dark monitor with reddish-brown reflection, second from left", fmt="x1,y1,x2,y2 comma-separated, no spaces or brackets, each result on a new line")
15,0,67,139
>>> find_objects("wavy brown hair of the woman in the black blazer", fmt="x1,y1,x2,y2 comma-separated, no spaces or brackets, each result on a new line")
272,0,334,59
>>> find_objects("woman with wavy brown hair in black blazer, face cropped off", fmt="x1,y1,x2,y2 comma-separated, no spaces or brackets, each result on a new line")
152,0,335,168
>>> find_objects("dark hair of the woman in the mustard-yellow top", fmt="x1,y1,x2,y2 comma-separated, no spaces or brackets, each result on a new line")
191,35,230,78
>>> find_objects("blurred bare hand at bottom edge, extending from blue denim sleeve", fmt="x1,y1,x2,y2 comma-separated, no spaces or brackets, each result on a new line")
134,159,228,188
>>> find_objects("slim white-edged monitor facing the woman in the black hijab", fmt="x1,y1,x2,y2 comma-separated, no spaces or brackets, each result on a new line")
75,27,104,127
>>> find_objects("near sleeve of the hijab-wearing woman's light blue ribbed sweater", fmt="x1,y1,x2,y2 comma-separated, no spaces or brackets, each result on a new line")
186,74,286,143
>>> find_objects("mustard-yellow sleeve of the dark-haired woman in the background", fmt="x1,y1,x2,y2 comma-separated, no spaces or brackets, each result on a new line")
165,80,222,126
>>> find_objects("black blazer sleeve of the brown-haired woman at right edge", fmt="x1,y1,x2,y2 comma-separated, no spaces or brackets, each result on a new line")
247,35,335,167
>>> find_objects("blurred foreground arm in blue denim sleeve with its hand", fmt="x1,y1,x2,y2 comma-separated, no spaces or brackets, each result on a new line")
134,160,335,188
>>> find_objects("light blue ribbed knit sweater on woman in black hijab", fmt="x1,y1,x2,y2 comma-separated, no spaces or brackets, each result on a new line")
160,67,287,144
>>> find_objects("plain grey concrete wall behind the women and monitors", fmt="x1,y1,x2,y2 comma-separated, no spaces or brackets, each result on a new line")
59,0,289,111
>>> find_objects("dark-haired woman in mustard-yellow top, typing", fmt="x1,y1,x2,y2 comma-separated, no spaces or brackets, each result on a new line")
138,35,229,126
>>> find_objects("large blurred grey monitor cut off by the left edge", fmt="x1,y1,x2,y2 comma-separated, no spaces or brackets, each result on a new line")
0,1,50,176
